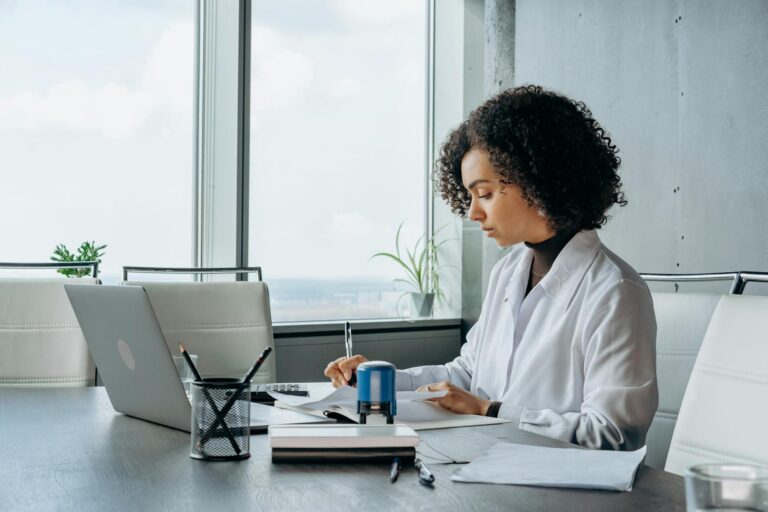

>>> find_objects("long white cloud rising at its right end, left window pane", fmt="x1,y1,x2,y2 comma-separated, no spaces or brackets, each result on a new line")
0,21,194,139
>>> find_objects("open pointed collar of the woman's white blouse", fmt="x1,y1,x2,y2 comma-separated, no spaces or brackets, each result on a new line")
510,230,602,310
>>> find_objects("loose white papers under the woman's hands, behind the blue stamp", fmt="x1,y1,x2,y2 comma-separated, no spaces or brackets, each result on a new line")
270,386,508,430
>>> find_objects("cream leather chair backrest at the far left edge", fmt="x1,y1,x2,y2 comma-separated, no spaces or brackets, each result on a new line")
0,278,97,387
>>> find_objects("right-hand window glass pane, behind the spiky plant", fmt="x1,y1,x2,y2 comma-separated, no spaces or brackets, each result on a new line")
249,0,426,321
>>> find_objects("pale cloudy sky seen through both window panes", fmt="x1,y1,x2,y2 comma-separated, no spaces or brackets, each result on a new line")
0,0,426,279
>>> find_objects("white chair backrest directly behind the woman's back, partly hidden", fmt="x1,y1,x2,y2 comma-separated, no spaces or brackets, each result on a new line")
646,292,721,468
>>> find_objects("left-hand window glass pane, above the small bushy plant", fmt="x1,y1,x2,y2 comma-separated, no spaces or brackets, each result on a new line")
0,0,195,283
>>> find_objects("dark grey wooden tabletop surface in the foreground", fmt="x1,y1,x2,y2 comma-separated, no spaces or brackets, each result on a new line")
0,388,685,512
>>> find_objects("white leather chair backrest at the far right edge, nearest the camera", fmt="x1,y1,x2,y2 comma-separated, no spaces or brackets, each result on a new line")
665,295,768,474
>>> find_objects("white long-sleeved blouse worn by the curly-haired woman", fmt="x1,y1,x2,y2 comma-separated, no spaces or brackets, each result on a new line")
397,231,658,450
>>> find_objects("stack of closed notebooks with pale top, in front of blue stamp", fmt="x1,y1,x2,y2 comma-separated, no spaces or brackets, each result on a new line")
269,424,419,464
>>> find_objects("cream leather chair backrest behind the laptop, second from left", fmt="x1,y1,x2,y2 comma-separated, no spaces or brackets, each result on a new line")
123,281,276,382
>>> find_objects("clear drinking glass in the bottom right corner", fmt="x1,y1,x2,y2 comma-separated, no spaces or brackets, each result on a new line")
685,464,768,512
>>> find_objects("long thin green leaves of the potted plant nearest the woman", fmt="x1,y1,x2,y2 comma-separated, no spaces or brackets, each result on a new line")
370,222,448,299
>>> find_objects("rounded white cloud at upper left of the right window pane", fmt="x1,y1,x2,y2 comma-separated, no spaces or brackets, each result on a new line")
251,26,314,111
